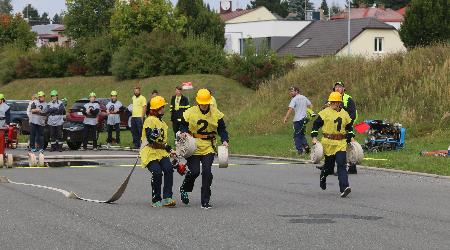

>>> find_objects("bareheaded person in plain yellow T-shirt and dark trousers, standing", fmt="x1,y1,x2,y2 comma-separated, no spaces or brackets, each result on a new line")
131,86,147,149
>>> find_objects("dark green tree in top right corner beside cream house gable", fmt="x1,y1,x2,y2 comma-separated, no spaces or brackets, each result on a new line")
400,0,450,48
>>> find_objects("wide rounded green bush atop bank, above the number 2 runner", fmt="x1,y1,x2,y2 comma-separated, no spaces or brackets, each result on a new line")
111,31,225,79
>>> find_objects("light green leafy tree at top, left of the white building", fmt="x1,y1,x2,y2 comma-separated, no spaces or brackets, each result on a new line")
111,0,186,43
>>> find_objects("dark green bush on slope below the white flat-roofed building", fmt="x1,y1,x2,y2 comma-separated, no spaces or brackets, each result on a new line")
224,40,295,89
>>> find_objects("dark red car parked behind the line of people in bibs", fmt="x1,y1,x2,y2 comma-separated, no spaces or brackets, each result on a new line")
67,98,130,131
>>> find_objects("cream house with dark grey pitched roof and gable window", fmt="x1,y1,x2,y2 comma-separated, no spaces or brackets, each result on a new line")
277,18,406,65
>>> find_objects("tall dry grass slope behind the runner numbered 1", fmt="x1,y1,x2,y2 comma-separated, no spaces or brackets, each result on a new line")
233,46,450,175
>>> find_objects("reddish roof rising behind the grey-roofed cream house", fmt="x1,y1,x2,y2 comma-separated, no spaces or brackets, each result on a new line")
331,8,403,22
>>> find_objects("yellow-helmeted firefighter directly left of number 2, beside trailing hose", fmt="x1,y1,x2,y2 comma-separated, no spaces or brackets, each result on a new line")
140,96,176,207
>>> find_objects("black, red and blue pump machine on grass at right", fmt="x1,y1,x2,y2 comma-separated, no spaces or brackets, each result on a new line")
363,120,406,152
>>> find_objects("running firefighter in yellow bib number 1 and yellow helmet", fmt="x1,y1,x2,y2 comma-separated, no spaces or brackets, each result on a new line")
311,92,354,198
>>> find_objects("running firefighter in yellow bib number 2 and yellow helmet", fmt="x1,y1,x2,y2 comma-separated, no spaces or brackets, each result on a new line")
180,89,228,209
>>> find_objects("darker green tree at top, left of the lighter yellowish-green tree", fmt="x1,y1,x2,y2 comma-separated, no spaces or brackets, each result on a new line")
63,0,115,40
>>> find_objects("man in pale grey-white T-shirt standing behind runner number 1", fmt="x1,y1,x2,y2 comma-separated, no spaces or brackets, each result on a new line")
284,87,312,154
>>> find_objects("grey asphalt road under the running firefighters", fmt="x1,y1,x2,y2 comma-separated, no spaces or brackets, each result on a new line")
0,153,450,249
